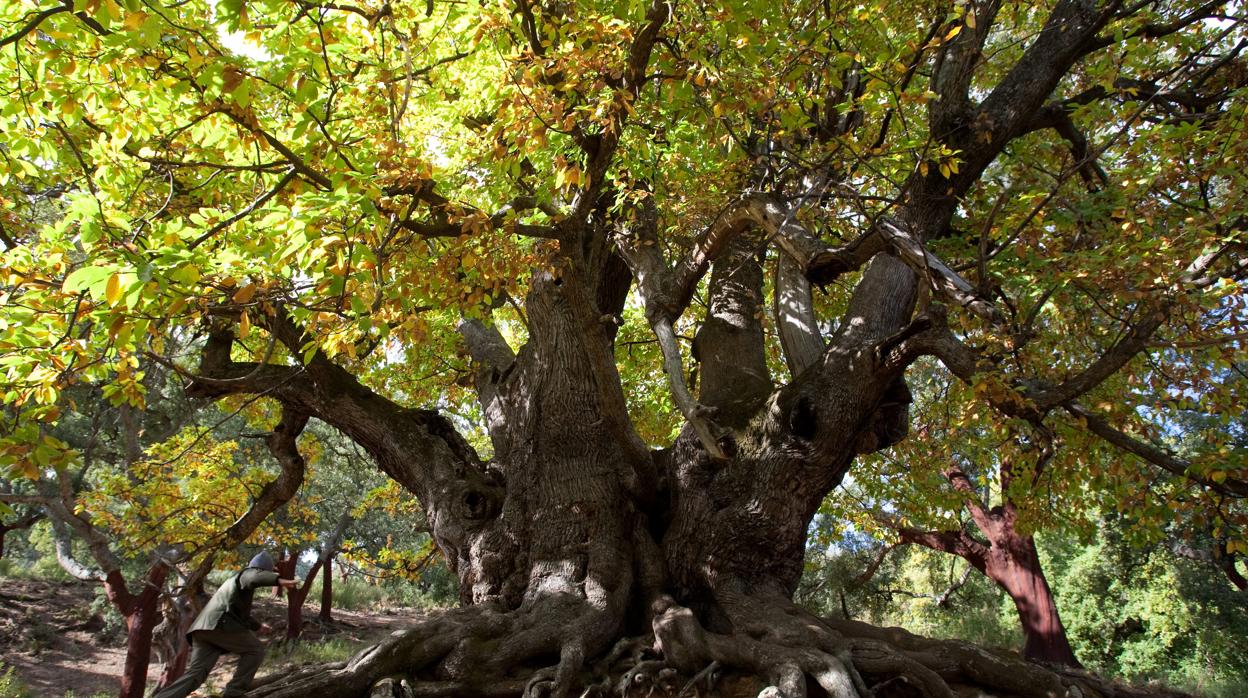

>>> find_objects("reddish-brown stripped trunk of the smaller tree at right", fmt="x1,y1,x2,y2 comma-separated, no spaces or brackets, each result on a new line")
985,528,1081,667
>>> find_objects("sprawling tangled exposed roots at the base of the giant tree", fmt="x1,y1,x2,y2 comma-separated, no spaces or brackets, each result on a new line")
240,598,1182,698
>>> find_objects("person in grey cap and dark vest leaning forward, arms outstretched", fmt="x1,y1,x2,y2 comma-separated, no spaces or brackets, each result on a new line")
152,552,298,698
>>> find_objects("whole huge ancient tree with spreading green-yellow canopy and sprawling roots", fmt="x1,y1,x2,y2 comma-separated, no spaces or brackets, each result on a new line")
0,0,1248,697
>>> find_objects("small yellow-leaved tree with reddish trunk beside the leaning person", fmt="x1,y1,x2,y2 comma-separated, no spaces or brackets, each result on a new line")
0,359,314,698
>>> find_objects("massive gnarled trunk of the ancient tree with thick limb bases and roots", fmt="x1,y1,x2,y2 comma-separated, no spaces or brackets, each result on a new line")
192,236,1123,697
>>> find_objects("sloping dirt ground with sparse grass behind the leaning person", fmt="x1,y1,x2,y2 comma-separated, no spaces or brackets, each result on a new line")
0,577,422,698
